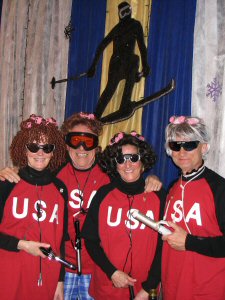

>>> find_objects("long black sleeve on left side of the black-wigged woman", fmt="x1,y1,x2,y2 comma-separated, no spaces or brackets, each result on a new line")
81,184,116,279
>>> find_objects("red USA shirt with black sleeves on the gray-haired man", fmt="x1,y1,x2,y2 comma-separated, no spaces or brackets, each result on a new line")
162,168,225,300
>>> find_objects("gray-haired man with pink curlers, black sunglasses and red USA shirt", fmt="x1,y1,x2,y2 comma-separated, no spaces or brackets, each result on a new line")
162,116,225,300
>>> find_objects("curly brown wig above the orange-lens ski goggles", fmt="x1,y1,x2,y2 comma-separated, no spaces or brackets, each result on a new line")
61,112,102,136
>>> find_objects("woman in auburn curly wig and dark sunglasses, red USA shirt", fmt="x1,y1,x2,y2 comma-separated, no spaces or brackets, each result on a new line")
0,115,67,300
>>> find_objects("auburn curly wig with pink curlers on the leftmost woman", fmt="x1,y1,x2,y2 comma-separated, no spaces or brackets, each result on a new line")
10,114,66,171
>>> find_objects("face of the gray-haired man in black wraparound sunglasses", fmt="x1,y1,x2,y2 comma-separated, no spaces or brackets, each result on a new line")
171,137,207,174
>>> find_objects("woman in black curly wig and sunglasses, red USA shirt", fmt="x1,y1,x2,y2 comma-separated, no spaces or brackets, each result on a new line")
82,131,164,300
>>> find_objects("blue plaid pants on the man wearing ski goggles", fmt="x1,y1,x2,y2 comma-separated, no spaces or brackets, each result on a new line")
64,272,94,300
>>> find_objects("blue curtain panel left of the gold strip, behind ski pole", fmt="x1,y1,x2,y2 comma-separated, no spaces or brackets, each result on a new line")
65,0,106,118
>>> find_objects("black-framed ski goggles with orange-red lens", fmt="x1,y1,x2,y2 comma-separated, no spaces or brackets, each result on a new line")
65,132,98,151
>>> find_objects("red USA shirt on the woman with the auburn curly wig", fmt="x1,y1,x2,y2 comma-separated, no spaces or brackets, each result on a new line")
0,179,65,300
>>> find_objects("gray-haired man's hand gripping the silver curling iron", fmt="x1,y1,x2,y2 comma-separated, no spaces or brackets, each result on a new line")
162,221,187,251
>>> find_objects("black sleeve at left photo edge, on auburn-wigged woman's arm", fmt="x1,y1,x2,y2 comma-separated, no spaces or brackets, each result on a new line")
0,180,19,252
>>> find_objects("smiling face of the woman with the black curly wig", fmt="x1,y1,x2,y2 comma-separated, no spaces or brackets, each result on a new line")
117,145,142,182
